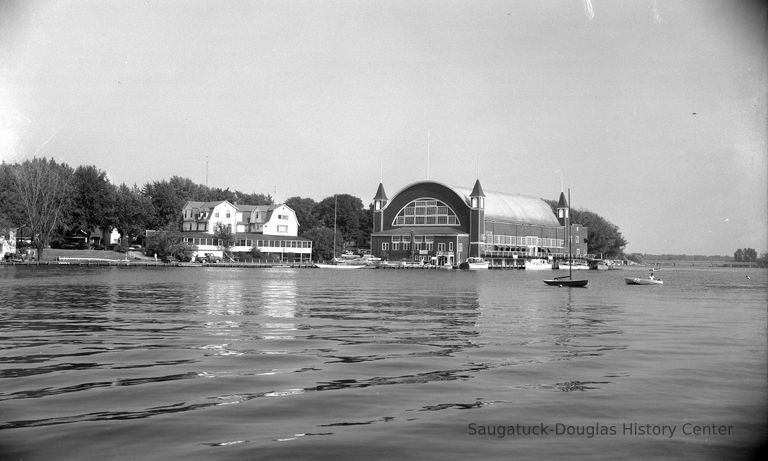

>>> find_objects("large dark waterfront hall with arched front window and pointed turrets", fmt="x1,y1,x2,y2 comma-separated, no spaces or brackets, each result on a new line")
371,180,587,266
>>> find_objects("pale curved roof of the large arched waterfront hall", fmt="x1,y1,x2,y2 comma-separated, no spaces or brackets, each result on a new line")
395,181,560,227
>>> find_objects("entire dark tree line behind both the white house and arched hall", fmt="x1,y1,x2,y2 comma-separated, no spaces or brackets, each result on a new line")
0,158,627,260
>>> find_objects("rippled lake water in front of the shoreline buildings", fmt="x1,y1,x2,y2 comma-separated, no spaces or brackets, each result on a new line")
0,266,768,460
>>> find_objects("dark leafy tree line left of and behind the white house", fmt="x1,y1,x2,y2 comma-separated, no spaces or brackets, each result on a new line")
0,158,272,257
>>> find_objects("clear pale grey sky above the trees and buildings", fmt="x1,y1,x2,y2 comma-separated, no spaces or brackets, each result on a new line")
0,0,768,255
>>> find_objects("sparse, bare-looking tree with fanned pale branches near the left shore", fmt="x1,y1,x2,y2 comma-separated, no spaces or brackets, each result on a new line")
13,158,73,260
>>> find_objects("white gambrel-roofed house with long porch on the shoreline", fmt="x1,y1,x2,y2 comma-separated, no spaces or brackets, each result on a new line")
181,200,312,261
